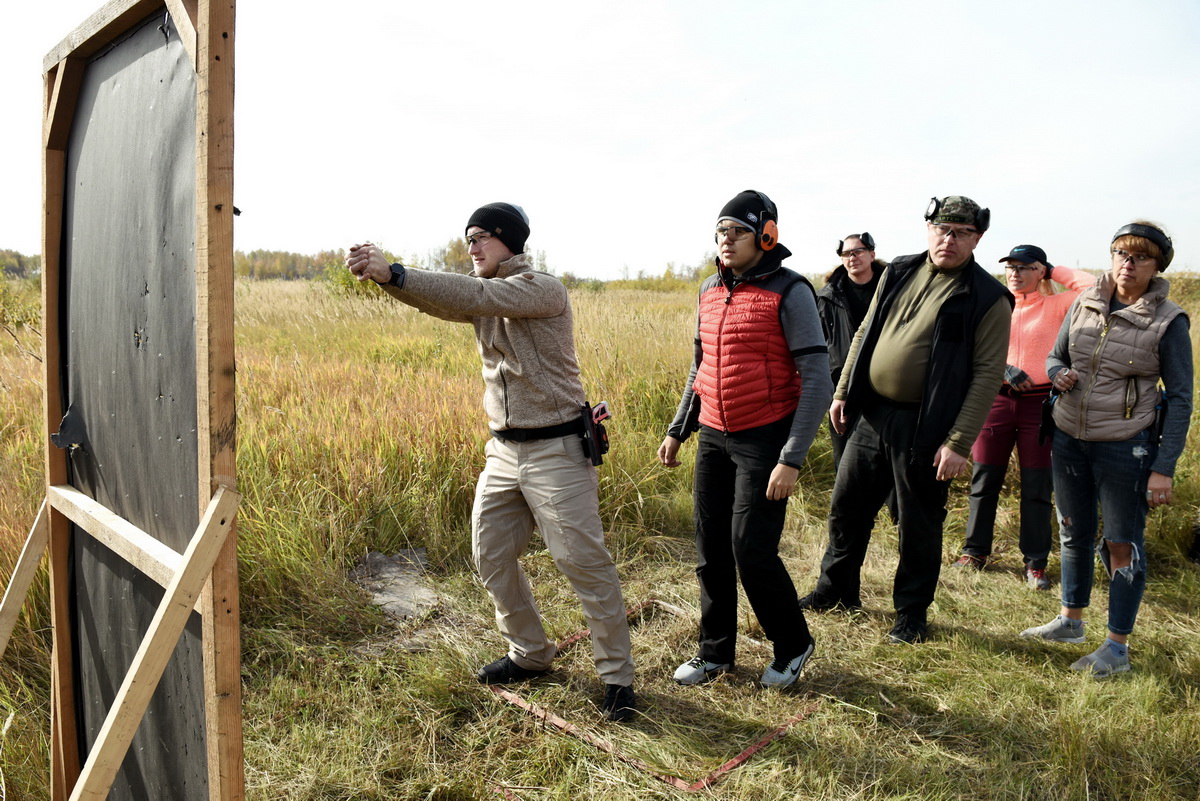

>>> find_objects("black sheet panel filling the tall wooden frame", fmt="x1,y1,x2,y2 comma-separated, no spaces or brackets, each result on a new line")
60,11,208,801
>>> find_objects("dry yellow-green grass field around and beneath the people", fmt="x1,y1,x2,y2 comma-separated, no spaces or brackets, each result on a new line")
0,276,1200,801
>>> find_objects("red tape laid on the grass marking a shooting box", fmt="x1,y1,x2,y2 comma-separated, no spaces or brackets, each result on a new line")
488,598,821,797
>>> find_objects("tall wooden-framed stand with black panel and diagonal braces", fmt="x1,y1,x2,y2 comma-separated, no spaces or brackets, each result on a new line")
24,0,238,801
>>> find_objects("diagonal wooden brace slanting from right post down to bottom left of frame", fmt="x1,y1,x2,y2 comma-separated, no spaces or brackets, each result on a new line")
71,488,240,801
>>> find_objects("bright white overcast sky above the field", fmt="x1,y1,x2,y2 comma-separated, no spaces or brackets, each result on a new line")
0,0,1200,278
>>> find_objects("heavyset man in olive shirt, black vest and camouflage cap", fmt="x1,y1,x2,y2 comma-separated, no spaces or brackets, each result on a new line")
802,195,1013,643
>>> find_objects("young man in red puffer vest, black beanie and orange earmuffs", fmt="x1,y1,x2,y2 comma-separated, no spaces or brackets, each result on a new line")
658,191,833,687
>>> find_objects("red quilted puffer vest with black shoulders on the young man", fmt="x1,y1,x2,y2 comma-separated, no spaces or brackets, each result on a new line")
692,262,804,433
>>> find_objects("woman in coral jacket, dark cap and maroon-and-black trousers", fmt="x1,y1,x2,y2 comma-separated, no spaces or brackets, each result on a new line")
955,245,1096,590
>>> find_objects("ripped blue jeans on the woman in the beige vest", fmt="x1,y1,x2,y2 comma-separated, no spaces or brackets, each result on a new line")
1054,430,1157,634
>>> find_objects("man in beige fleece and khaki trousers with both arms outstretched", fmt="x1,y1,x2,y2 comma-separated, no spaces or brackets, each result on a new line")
346,203,635,721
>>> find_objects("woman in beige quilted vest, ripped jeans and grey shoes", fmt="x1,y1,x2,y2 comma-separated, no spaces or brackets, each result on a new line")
1021,222,1192,677
